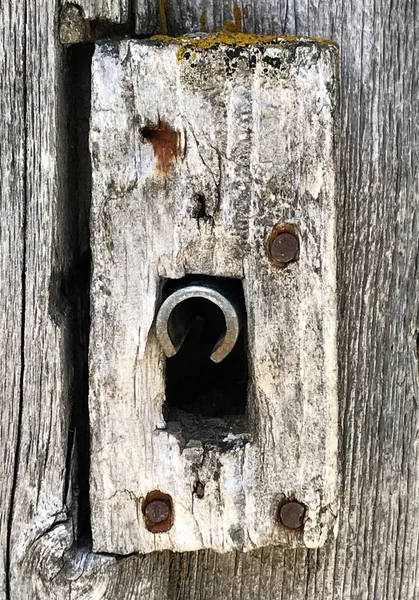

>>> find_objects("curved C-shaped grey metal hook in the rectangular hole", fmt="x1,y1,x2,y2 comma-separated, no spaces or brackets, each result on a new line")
156,282,242,363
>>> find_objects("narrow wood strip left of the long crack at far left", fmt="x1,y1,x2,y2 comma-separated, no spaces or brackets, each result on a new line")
0,2,25,598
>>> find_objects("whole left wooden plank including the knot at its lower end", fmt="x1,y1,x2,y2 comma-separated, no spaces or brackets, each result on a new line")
0,0,170,600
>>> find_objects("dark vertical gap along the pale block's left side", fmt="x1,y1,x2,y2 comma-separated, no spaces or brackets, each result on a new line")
67,44,94,547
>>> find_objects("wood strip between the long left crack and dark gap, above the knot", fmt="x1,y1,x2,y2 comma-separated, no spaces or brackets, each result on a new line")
9,0,73,598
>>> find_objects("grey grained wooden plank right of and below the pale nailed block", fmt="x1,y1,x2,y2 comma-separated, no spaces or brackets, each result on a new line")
140,1,419,600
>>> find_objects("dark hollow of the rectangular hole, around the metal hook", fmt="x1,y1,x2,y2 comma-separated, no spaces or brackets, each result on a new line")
163,276,247,439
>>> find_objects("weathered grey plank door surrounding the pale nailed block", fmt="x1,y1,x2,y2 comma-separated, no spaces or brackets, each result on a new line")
0,0,419,600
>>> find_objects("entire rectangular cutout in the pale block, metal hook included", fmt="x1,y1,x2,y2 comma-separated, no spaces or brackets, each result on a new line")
156,275,249,443
